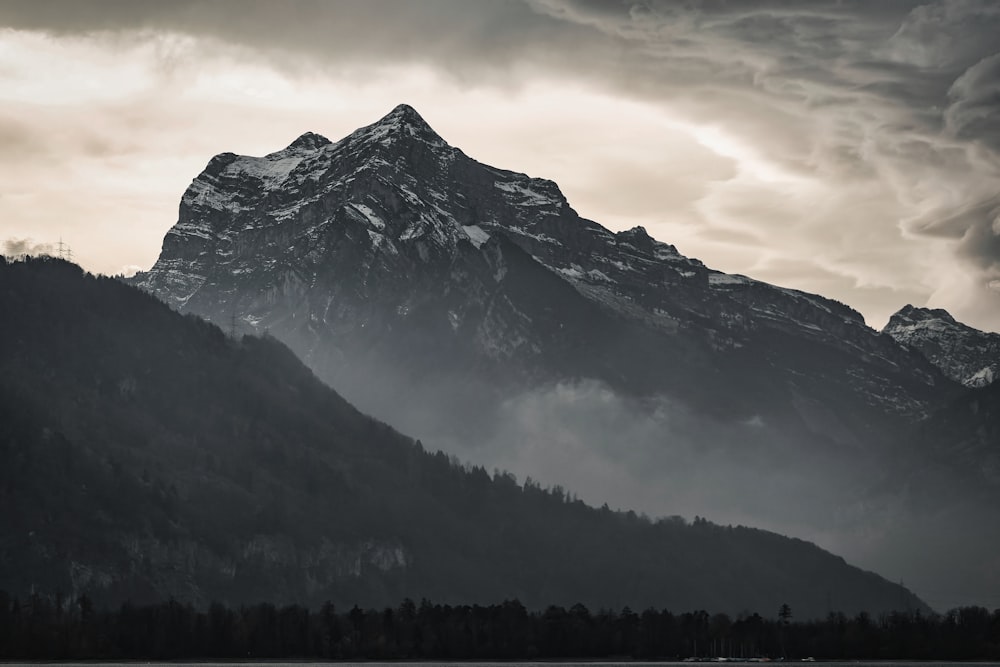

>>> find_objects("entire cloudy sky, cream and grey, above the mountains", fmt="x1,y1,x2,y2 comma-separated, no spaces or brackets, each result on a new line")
0,0,1000,331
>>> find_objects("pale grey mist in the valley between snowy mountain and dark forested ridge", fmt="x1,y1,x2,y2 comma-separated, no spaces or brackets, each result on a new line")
314,352,1000,611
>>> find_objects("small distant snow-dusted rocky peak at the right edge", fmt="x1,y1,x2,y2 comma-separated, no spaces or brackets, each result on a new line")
882,305,1000,387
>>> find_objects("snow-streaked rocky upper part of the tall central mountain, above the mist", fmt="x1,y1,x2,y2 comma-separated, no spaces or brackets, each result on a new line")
134,105,946,438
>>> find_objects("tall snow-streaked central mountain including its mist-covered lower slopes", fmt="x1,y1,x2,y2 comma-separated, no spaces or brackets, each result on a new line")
132,105,1000,604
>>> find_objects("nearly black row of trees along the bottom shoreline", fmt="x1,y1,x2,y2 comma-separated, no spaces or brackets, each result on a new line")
0,591,1000,660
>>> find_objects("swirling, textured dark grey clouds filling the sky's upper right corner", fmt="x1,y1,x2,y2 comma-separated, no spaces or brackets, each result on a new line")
524,0,1000,326
